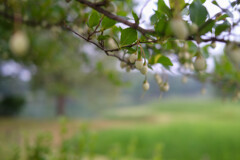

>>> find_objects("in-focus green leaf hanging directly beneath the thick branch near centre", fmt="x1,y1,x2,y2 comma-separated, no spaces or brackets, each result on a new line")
120,28,137,45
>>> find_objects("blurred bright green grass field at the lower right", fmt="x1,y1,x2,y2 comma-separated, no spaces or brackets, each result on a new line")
93,99,240,160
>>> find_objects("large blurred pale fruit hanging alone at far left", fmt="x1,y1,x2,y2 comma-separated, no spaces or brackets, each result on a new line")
9,31,29,56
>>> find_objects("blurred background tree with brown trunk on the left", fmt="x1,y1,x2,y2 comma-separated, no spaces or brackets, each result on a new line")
0,0,122,115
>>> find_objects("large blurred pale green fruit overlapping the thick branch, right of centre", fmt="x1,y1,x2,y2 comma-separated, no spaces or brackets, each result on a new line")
170,18,189,40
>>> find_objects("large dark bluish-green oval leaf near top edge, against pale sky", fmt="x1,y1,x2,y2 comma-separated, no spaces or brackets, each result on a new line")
189,0,208,26
